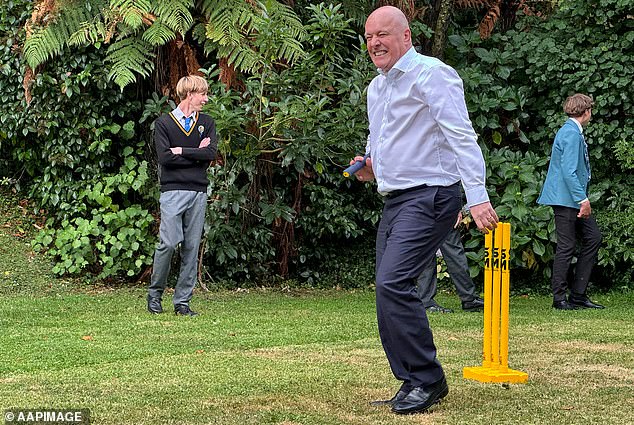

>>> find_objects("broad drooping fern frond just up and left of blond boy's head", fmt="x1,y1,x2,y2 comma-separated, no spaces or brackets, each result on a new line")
106,37,156,90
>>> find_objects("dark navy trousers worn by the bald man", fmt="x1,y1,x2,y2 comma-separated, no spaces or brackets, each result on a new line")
376,183,461,390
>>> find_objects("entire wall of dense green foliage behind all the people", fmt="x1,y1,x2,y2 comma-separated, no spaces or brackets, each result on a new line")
0,0,634,288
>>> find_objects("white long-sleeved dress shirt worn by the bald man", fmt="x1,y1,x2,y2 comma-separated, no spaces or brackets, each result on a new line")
366,47,489,206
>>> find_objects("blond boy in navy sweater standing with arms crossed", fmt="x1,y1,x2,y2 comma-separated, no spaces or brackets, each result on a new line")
147,75,217,316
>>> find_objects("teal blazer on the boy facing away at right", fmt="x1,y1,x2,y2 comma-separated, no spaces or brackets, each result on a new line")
537,119,590,209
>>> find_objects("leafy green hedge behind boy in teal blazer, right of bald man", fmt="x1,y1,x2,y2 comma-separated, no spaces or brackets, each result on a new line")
451,0,634,286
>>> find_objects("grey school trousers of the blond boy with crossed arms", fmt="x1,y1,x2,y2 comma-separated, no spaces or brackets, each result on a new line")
148,190,207,306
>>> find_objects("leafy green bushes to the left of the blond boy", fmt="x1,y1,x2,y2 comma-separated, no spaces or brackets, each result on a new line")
0,1,156,277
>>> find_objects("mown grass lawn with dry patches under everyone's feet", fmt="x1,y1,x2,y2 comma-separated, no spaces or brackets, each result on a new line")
0,194,634,425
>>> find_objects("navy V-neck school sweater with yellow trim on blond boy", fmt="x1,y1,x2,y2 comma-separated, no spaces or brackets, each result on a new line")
154,112,218,192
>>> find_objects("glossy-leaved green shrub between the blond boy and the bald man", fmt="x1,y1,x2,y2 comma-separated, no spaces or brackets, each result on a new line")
200,5,379,284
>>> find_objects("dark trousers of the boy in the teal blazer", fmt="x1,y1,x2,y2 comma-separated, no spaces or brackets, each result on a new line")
551,206,601,301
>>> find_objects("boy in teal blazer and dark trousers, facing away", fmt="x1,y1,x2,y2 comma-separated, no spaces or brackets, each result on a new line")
537,93,604,310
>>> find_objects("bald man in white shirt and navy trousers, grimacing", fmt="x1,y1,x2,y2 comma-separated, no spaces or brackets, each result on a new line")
351,6,498,414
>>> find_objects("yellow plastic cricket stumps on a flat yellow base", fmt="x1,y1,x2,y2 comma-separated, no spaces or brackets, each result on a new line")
462,223,528,384
